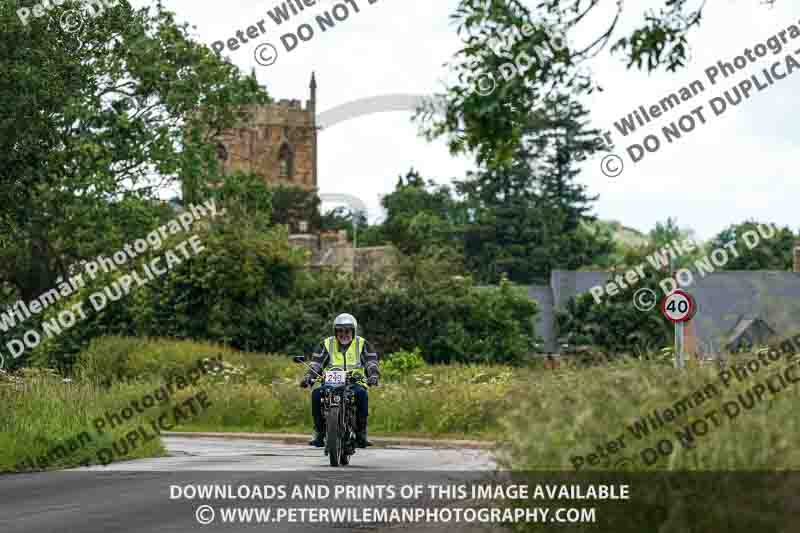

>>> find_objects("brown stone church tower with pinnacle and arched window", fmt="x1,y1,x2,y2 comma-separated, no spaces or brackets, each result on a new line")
217,73,317,191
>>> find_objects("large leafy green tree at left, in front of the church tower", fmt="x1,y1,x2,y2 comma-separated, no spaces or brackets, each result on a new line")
0,0,268,300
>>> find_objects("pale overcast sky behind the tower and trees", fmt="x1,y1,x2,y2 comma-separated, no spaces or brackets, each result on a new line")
145,0,800,239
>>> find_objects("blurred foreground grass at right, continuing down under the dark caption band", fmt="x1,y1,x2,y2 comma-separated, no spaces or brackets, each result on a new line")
500,358,800,533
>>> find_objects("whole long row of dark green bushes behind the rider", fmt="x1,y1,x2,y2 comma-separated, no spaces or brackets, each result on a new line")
26,214,536,373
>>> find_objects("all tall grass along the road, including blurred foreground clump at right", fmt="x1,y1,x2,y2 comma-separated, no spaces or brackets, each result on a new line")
10,337,800,478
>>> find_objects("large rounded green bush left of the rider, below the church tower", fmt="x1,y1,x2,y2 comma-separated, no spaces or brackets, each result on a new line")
28,214,302,372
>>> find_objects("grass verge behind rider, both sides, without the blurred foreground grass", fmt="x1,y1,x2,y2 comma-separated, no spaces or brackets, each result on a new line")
0,337,532,471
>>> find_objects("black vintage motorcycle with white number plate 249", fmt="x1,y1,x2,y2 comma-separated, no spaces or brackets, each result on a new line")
294,355,364,466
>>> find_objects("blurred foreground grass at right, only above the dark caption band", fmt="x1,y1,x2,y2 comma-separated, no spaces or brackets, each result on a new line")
503,357,800,471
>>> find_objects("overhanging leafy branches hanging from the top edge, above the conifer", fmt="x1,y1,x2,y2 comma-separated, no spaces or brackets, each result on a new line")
417,0,774,165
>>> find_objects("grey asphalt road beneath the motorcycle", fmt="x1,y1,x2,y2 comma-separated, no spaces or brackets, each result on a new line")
0,437,495,533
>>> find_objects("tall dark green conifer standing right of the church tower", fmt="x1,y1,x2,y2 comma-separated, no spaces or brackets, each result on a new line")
457,97,613,284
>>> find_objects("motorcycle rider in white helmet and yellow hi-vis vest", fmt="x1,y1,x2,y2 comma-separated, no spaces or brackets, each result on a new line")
300,313,380,448
